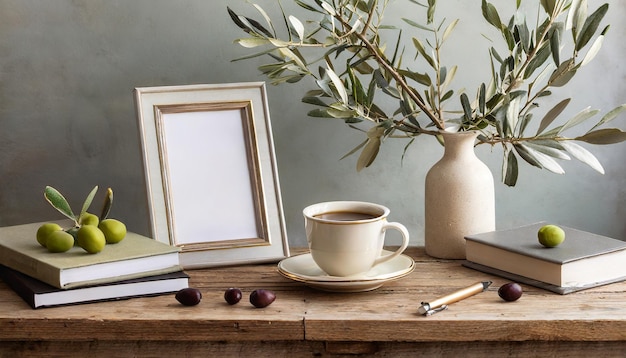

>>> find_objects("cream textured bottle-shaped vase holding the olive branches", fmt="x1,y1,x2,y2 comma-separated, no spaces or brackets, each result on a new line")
424,132,495,259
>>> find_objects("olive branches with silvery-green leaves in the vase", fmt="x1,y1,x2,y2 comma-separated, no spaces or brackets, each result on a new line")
228,0,626,186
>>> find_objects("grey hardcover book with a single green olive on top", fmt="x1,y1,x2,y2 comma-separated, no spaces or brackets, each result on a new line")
464,222,626,294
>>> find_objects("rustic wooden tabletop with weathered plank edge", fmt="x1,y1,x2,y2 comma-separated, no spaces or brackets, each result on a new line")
0,248,626,357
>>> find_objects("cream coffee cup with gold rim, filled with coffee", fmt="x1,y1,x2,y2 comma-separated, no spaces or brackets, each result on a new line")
303,201,409,277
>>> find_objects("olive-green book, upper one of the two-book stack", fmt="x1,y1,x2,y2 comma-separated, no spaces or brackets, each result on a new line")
0,222,182,289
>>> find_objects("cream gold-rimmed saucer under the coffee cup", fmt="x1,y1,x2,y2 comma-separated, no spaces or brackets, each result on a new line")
278,250,415,292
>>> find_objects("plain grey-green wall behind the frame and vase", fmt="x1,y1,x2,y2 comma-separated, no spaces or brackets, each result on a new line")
0,0,626,246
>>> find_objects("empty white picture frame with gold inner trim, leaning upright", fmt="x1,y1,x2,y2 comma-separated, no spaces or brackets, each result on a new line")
134,82,289,269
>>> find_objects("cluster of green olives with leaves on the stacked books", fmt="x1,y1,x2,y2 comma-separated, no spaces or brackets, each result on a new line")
36,186,126,254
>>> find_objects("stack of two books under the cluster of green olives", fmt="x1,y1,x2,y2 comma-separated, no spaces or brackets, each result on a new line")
0,222,189,308
